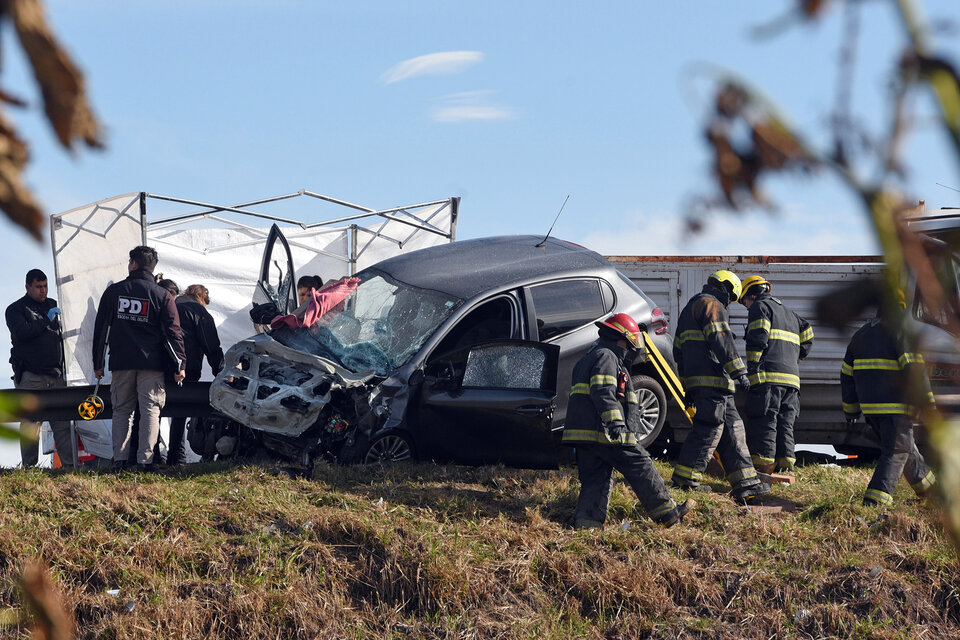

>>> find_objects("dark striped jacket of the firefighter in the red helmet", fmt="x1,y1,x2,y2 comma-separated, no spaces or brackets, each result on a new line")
563,338,640,446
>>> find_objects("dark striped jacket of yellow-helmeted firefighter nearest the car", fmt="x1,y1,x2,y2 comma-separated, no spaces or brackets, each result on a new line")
673,285,747,393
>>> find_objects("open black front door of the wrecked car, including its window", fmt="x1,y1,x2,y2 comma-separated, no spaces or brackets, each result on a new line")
418,340,562,467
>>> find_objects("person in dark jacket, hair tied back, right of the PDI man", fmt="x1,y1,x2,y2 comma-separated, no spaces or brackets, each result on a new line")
167,284,223,465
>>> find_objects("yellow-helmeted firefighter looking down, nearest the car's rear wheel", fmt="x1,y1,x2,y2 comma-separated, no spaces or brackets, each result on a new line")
673,269,770,504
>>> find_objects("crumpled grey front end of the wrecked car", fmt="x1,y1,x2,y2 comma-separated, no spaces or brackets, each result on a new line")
210,334,375,436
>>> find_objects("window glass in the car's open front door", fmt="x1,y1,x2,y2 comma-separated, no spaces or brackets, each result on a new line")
463,344,547,389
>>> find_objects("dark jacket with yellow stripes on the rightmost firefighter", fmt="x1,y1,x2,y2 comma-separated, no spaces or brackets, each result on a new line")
840,318,933,416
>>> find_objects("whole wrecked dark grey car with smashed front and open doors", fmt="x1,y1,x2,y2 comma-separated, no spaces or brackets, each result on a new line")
205,229,672,467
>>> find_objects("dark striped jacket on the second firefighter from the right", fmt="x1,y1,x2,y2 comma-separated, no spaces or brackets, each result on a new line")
744,293,813,389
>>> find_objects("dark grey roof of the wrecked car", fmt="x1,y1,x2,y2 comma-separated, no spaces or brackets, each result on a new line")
371,236,613,300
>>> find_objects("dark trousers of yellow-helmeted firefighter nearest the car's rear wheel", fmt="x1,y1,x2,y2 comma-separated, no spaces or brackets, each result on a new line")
673,387,760,489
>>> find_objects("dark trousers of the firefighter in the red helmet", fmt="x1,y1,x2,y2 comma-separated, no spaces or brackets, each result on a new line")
575,444,677,528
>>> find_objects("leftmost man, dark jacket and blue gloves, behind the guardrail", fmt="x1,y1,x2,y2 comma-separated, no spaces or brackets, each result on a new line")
5,269,74,467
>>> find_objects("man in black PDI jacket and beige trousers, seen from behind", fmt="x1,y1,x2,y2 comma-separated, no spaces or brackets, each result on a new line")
93,246,186,470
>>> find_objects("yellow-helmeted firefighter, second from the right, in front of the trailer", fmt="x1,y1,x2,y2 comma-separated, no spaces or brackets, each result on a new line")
740,276,813,473
